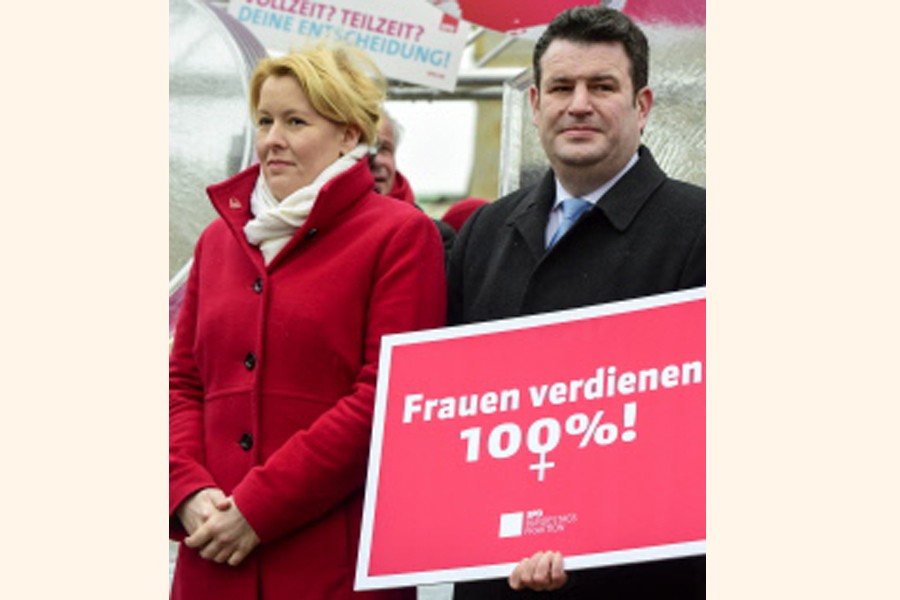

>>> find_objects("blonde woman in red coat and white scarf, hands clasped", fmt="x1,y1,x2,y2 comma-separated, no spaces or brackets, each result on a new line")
169,46,446,600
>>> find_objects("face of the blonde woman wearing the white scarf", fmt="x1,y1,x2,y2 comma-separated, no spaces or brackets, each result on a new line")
256,76,360,201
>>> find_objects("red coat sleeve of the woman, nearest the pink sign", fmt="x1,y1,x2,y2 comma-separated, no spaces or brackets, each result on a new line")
232,211,446,542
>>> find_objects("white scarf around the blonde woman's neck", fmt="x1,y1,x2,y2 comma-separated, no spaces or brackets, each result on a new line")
244,144,368,264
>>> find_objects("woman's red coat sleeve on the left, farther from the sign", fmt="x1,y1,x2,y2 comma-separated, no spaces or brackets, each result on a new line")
169,240,217,539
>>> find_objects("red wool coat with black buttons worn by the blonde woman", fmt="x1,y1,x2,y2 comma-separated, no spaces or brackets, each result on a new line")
169,161,446,600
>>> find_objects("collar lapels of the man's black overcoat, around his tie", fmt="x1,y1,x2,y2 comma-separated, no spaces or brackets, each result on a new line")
506,145,666,256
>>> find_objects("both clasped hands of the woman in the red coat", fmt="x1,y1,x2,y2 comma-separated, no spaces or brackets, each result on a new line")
176,488,259,567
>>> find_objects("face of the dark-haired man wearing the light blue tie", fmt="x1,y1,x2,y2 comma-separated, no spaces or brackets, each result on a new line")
529,40,653,180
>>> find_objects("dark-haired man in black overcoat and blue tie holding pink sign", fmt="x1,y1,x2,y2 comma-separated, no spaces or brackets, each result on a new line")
448,6,706,600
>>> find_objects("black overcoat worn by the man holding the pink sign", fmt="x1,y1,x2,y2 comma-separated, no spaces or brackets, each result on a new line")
448,146,706,600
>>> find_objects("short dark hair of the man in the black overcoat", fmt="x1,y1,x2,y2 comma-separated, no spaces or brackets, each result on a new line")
532,6,650,94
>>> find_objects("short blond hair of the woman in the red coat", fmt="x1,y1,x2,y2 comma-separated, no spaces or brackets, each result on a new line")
250,42,387,146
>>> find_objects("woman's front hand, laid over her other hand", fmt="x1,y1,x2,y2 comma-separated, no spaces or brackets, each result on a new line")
184,496,259,567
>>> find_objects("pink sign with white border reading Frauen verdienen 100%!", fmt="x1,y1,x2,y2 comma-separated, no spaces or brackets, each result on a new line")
356,288,706,589
